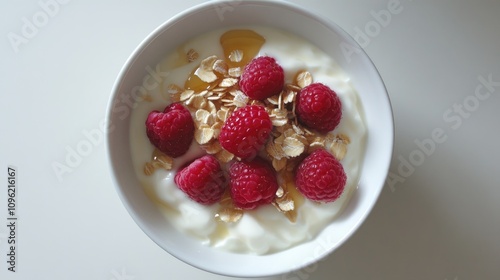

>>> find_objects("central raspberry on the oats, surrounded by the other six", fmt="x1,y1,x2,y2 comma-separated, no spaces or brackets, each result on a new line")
219,105,273,159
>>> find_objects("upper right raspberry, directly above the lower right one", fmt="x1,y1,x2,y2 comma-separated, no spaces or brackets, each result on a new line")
297,83,342,133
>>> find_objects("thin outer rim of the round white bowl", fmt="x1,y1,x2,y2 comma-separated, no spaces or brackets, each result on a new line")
105,0,395,277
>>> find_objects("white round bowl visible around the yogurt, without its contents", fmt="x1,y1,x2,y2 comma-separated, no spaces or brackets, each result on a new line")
106,0,394,277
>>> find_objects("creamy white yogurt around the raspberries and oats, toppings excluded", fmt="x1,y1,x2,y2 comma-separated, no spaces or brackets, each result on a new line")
130,26,366,254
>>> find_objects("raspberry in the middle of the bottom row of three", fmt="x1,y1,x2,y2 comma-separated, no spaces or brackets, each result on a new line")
229,158,278,210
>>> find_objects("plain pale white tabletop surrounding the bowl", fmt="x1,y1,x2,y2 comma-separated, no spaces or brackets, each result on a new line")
0,0,500,280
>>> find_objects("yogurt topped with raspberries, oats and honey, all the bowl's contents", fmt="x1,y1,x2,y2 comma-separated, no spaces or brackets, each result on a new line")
130,25,368,255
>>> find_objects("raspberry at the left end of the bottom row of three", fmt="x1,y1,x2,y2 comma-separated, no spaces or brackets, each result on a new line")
175,155,227,205
